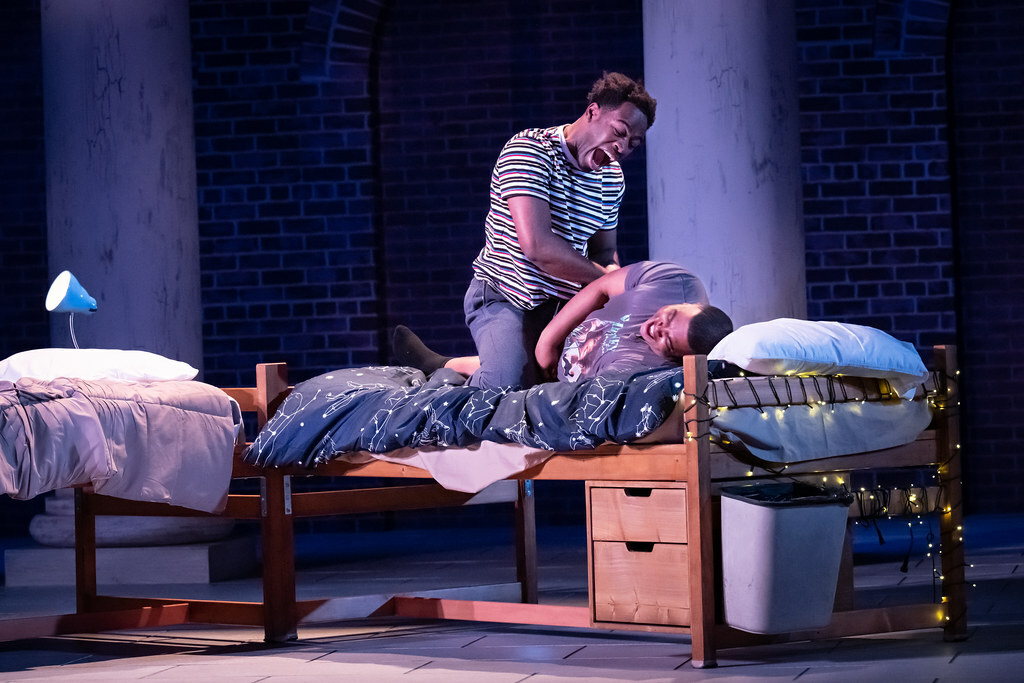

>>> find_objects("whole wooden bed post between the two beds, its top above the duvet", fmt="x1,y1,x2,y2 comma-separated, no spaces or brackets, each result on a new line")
256,362,299,642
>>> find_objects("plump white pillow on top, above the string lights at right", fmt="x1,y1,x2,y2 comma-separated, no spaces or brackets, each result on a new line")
708,317,928,398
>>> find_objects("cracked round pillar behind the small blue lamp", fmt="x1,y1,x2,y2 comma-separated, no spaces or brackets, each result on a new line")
39,0,203,368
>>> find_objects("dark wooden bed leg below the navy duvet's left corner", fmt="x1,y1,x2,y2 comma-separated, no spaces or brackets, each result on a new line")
260,470,298,642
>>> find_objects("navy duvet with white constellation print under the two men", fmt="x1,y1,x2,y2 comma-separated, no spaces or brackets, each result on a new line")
245,367,683,467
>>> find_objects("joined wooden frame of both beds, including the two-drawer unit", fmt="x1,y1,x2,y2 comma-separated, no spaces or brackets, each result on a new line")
0,346,967,668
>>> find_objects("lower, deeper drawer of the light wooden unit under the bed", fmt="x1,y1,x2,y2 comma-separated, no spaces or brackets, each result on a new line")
592,541,690,626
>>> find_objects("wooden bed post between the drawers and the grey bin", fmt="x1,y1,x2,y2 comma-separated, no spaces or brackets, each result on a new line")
679,355,718,669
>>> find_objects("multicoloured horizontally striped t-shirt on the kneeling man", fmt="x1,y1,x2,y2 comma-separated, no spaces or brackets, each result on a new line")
473,126,625,309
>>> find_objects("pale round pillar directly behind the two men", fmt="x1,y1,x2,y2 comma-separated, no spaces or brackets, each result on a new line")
643,0,807,326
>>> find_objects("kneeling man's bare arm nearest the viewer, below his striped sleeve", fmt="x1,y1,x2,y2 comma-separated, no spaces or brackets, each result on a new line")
509,196,606,285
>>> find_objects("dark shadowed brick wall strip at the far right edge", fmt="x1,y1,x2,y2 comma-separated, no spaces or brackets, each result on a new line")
952,0,1024,512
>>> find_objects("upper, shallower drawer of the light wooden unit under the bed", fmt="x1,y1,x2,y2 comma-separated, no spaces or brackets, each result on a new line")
588,484,686,543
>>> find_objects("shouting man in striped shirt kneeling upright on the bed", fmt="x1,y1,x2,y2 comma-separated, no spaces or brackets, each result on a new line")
464,73,656,387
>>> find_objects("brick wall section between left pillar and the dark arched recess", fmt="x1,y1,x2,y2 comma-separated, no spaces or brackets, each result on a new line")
190,0,381,384
